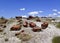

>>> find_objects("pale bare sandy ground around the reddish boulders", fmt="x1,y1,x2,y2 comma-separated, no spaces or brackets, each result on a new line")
0,19,60,43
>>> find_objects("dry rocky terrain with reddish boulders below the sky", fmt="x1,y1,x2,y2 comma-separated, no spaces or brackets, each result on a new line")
0,16,60,43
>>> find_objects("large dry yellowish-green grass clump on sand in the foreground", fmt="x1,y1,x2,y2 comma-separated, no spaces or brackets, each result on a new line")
17,30,32,41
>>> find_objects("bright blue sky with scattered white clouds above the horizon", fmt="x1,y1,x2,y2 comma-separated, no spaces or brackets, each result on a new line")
0,0,60,18
